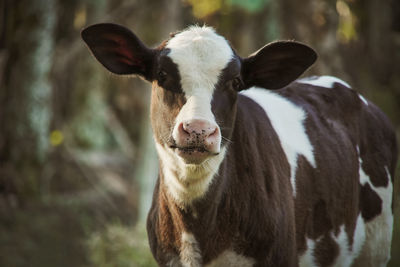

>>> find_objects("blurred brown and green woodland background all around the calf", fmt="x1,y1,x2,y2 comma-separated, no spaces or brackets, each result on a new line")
0,0,400,267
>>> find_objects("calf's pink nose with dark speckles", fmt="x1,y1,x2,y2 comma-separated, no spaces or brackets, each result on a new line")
175,119,221,153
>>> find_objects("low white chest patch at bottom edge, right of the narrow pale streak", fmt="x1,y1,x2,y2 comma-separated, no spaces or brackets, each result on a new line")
205,250,256,267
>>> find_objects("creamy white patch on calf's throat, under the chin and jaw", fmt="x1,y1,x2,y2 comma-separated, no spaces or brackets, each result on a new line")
156,143,226,207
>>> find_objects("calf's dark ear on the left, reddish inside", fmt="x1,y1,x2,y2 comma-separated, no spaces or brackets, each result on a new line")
81,23,156,80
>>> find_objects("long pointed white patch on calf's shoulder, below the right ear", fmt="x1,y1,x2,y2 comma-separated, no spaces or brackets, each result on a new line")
240,87,316,196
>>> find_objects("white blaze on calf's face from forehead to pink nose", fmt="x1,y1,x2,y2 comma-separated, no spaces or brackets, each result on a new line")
166,26,233,144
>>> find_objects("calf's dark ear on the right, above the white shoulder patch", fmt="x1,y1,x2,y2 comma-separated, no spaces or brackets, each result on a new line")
241,41,317,89
